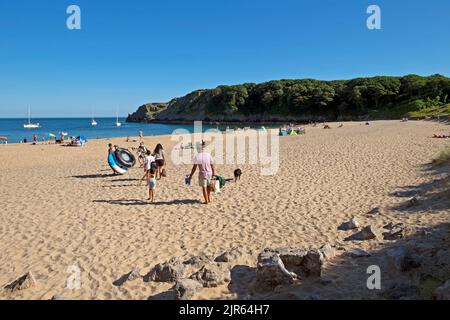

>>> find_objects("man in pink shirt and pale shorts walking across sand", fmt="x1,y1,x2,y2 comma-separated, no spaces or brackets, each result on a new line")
189,141,216,204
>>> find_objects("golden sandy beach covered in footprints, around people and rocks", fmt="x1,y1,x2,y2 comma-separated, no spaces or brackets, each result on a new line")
0,121,450,299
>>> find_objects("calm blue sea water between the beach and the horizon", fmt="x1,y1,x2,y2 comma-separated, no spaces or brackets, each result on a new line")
0,118,227,143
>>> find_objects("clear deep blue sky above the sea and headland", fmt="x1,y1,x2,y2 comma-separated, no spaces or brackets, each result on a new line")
0,0,450,117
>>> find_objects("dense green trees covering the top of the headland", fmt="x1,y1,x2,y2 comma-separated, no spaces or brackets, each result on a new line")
202,75,450,117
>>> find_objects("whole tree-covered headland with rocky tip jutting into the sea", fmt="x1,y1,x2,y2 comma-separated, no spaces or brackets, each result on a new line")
127,75,450,122
